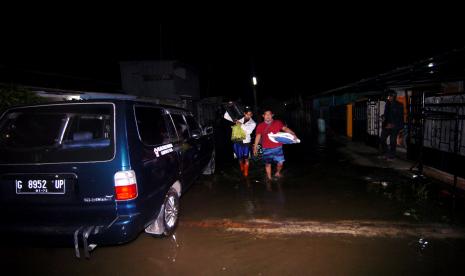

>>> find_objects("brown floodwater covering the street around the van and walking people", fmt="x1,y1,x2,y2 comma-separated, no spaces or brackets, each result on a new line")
0,134,465,275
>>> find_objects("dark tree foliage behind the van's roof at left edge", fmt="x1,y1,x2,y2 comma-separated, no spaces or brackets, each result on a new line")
0,85,44,113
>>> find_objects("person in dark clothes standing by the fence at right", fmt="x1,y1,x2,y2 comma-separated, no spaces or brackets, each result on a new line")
380,90,404,160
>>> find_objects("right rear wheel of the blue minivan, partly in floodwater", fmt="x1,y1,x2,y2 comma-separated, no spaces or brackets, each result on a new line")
145,188,179,237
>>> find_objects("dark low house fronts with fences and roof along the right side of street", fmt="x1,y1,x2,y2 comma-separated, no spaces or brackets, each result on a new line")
312,48,465,185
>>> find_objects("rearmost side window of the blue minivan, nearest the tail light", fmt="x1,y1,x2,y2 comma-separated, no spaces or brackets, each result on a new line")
135,106,170,145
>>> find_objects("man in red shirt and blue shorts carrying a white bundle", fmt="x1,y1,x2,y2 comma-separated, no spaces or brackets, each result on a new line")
253,109,295,180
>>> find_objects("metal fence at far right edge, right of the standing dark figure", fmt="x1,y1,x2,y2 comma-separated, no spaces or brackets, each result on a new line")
409,92,465,177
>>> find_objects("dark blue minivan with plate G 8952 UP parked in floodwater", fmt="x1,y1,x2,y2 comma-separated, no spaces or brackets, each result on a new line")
0,100,215,257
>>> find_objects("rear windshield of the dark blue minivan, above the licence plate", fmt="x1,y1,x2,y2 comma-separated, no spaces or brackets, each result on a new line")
0,103,114,164
